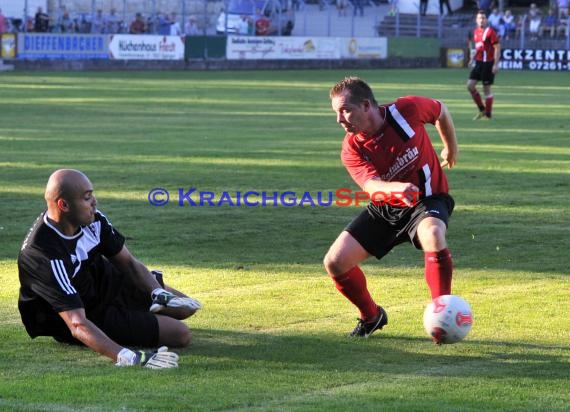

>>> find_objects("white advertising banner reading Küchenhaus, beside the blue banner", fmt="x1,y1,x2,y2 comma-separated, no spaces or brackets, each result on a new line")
109,34,184,60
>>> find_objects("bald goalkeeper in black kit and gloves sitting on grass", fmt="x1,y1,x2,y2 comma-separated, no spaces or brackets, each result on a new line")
18,169,200,368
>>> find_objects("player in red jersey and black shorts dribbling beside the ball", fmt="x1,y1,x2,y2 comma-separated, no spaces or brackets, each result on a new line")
324,77,458,337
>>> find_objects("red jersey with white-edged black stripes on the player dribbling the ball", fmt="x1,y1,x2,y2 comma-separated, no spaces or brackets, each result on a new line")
341,96,449,198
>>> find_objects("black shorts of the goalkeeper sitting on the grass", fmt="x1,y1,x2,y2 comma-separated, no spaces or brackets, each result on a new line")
54,269,164,348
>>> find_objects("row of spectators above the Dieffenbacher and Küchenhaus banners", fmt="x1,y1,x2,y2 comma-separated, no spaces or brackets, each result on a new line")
0,7,200,36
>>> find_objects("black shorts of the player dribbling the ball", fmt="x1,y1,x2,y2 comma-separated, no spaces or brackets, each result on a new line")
345,194,455,259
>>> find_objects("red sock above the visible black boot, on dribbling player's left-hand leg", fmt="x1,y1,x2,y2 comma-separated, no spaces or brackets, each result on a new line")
332,266,378,320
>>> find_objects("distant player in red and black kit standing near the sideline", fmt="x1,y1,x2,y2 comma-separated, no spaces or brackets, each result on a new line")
467,10,501,120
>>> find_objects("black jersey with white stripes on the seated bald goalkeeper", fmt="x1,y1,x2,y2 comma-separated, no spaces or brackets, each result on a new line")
18,211,125,338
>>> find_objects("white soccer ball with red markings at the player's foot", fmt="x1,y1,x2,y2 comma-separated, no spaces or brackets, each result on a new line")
424,295,473,345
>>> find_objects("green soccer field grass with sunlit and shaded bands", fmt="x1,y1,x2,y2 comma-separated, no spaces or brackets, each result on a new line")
0,70,570,411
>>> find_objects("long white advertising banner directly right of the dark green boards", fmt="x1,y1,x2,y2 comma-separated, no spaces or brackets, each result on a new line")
226,36,340,60
